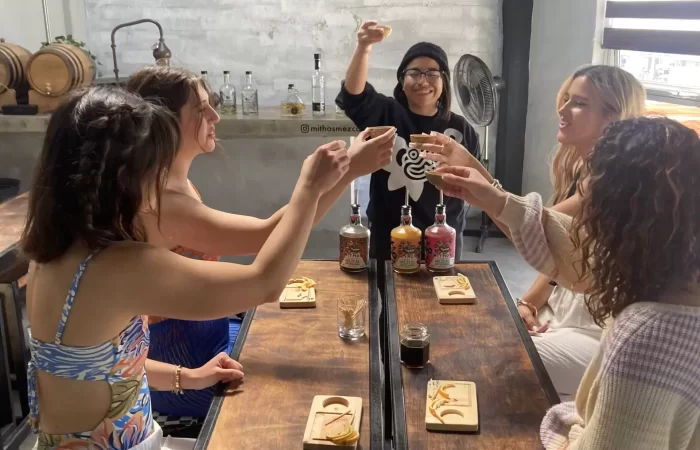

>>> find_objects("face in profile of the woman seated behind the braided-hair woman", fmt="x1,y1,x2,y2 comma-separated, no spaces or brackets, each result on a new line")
180,84,220,153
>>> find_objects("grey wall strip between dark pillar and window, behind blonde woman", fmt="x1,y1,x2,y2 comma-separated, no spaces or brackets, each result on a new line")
523,0,596,199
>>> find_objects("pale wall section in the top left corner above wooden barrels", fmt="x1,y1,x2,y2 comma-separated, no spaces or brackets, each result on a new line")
0,0,86,52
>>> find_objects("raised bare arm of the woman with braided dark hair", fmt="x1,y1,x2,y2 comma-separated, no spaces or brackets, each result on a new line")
124,141,349,320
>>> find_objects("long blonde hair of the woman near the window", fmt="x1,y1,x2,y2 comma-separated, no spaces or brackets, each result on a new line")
550,65,646,205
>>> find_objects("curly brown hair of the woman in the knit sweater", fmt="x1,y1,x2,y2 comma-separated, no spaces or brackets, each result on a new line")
571,117,700,326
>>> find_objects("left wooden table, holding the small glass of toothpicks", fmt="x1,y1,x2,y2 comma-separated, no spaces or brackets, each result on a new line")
195,260,384,450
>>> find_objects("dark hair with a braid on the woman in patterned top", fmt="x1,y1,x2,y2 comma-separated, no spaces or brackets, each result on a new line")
22,86,180,263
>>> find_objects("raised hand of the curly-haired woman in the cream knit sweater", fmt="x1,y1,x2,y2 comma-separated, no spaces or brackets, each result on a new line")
435,166,508,217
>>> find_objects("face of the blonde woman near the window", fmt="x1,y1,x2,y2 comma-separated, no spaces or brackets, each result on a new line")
557,76,611,152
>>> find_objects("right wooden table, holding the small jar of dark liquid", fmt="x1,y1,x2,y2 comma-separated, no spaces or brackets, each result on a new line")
384,262,559,450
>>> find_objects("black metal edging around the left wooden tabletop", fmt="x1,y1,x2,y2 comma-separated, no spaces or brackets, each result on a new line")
194,258,385,450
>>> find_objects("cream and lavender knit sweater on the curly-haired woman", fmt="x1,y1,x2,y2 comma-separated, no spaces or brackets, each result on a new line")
498,194,700,450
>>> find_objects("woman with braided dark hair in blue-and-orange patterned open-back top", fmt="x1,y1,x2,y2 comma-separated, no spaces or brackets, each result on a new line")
22,87,349,450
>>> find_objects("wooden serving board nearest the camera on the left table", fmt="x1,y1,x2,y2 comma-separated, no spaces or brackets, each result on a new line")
303,395,362,450
